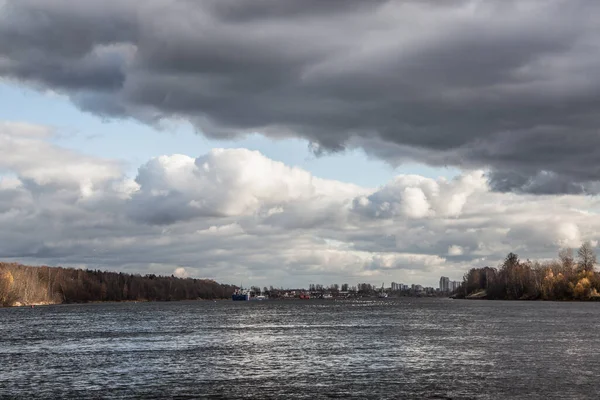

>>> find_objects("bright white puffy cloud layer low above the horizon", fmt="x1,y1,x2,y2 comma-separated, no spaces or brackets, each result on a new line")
0,123,600,286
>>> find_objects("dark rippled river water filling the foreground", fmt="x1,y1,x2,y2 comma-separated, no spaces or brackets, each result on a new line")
0,299,600,399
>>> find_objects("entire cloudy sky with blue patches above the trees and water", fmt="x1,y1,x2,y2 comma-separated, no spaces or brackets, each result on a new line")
0,0,600,287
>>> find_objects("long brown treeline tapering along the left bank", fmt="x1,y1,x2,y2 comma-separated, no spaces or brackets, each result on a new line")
0,263,235,306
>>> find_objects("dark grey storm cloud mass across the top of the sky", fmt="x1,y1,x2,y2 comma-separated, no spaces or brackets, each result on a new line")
0,0,600,193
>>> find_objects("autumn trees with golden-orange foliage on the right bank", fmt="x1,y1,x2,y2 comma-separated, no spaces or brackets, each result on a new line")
454,242,600,300
